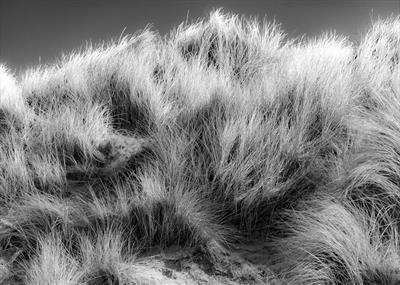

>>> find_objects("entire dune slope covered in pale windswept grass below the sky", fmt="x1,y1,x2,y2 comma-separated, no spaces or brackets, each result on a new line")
0,11,400,284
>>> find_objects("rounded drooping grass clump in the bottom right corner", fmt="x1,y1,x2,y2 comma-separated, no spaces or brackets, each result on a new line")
271,196,400,284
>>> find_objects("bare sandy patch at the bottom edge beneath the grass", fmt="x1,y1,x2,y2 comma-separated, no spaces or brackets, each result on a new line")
131,242,281,284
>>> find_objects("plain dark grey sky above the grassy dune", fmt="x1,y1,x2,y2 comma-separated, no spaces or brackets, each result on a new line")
0,0,400,70
